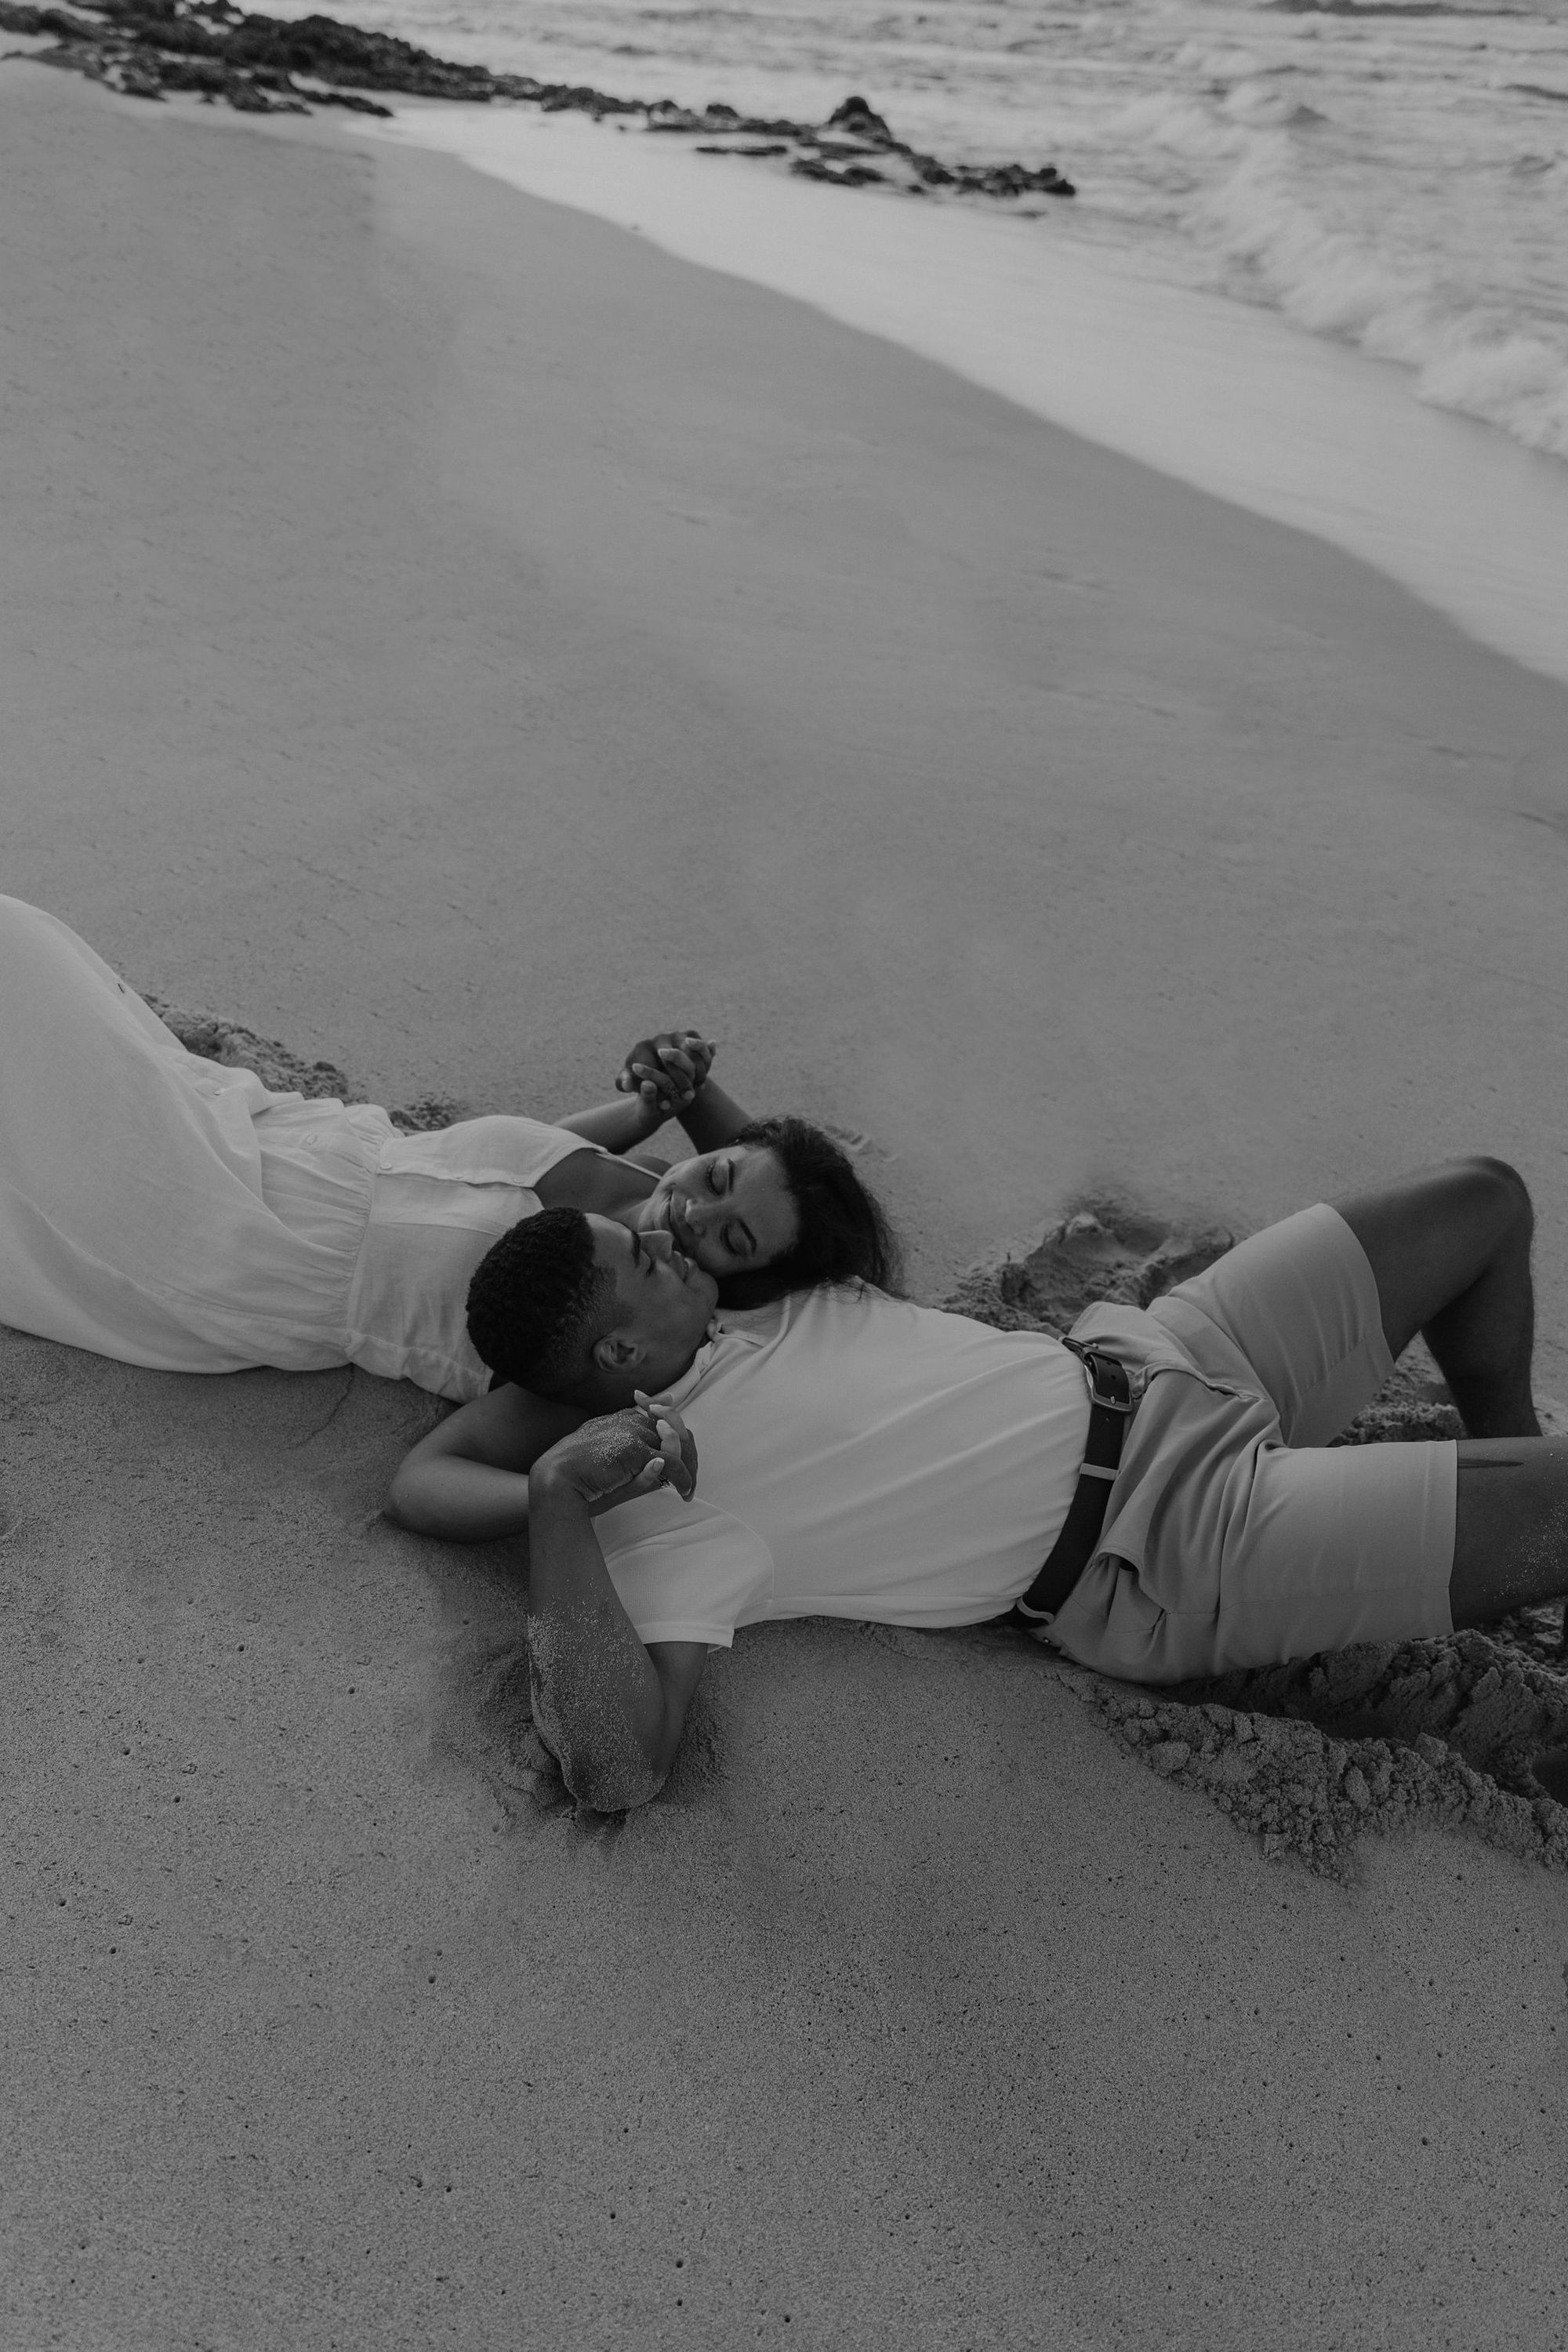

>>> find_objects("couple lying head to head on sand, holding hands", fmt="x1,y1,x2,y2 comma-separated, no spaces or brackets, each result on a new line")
0,901,1568,1811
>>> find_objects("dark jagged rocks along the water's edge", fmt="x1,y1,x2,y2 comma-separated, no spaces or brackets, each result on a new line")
0,0,1074,202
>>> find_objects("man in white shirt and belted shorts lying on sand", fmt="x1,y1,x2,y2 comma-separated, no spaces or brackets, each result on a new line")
390,1160,1568,1811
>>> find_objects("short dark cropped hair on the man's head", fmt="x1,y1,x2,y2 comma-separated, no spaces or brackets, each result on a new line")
468,1209,616,1397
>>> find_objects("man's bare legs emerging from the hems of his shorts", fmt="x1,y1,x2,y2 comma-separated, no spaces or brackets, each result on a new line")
1333,1160,1568,1625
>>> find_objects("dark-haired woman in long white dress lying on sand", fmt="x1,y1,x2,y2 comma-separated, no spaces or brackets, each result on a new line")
0,896,893,1399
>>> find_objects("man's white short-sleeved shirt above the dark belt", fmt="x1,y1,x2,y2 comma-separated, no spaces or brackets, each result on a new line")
595,1289,1088,1646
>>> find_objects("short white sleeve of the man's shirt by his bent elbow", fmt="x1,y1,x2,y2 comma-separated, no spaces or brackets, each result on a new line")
595,1494,774,1649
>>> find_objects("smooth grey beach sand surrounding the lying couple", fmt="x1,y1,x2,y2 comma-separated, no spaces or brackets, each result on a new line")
0,66,1568,2352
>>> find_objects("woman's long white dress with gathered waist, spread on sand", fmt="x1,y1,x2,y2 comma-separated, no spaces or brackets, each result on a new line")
0,896,597,1399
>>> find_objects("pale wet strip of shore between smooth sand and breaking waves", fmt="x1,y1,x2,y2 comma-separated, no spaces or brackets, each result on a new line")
372,99,1568,684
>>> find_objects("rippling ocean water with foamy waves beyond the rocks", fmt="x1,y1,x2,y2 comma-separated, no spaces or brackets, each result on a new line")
270,0,1568,459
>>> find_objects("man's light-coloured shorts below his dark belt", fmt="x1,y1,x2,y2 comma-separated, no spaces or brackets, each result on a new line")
1046,1204,1457,1682
